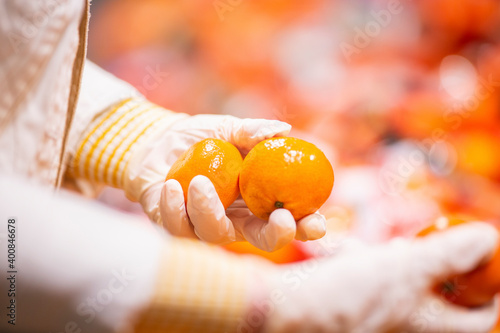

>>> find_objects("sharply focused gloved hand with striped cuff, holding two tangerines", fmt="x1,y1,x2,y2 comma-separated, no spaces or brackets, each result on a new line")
75,100,326,251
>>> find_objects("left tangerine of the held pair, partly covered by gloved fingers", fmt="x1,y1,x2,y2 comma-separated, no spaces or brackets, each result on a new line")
165,139,243,209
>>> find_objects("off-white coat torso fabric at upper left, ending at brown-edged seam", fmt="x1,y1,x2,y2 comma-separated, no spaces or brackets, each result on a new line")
0,0,85,185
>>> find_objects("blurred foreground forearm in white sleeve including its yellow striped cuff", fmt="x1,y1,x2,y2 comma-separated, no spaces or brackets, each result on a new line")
0,177,268,333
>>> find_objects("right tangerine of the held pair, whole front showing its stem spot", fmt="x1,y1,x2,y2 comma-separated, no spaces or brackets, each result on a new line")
240,137,334,220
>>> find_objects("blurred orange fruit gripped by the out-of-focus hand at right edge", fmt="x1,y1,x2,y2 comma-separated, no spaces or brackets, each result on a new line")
417,217,500,307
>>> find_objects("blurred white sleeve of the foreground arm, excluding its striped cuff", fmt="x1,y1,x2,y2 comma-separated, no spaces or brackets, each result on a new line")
0,176,163,333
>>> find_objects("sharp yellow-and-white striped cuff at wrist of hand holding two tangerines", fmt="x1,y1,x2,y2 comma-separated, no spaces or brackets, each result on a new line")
70,99,172,188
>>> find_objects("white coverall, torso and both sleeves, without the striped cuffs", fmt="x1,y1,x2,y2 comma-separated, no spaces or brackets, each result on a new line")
0,0,160,332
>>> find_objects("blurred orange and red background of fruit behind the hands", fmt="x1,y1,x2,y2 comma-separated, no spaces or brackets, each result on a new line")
88,0,500,248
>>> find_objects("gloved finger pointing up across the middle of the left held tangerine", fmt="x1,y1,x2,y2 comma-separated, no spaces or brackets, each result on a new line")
187,175,235,244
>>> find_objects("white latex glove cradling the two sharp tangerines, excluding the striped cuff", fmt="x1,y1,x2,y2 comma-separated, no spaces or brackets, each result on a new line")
124,115,326,251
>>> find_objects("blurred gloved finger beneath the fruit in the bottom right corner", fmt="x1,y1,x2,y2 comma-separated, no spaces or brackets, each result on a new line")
408,296,499,333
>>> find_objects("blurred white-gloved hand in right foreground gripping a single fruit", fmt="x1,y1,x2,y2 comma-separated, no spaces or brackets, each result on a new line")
256,223,498,333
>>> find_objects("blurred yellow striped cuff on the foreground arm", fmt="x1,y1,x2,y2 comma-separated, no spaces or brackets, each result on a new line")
135,238,267,333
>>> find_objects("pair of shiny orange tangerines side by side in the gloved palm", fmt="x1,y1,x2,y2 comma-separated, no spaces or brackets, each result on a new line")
166,137,334,220
